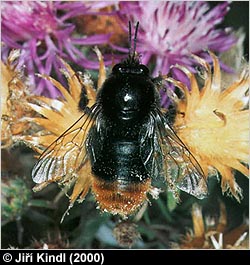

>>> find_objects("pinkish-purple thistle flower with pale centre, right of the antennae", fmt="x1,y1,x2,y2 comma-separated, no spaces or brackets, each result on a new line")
116,1,236,104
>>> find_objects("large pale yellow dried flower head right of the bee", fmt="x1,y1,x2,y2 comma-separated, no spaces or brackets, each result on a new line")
168,53,249,200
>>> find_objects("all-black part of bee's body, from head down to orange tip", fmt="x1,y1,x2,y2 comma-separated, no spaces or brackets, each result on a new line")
87,63,159,182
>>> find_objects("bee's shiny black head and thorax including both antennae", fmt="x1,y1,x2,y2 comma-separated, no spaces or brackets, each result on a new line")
97,22,159,123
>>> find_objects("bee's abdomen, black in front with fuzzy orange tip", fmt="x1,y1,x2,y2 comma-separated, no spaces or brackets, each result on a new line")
89,140,151,217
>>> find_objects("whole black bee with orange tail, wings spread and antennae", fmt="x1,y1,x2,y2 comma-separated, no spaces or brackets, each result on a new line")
32,23,207,217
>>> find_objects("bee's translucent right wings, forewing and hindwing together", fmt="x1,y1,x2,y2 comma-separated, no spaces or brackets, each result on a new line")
142,110,207,199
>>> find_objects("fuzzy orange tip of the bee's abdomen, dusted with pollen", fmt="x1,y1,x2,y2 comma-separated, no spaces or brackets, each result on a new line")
92,177,151,217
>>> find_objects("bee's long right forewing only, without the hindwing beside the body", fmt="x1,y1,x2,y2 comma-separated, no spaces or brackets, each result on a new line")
157,109,207,199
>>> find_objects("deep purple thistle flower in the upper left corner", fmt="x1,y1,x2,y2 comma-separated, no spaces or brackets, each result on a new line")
1,1,109,98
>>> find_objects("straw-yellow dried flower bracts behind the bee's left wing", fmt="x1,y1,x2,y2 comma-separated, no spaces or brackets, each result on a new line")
22,49,106,212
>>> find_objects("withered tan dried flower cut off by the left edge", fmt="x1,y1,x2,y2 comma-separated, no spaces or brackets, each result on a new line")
1,50,34,148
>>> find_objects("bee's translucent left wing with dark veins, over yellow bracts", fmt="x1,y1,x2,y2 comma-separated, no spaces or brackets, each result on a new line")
32,106,98,184
